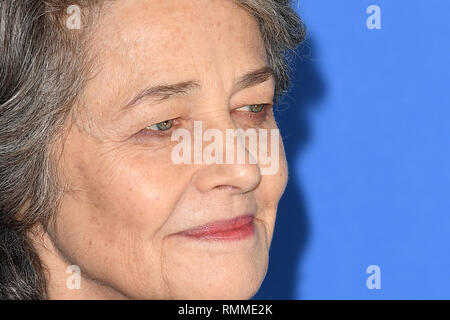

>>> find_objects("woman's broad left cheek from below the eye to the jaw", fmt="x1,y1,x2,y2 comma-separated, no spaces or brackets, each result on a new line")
57,143,192,297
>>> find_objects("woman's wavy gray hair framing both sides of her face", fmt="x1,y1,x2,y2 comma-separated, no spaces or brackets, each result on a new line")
0,0,305,299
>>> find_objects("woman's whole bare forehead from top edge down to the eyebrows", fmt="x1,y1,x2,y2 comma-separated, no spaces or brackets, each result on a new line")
83,0,266,109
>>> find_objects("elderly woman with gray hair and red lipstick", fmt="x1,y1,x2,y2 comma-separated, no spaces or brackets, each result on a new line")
0,0,304,299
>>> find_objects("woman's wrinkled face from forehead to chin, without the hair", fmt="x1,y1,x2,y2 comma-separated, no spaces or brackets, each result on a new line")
50,0,287,299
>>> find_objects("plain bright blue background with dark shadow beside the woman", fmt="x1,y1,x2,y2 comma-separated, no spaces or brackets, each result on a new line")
255,0,450,299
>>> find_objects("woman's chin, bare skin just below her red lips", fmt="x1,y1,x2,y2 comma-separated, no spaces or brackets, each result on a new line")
163,235,268,300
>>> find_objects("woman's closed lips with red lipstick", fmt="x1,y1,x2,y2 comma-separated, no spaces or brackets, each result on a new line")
181,215,254,241
